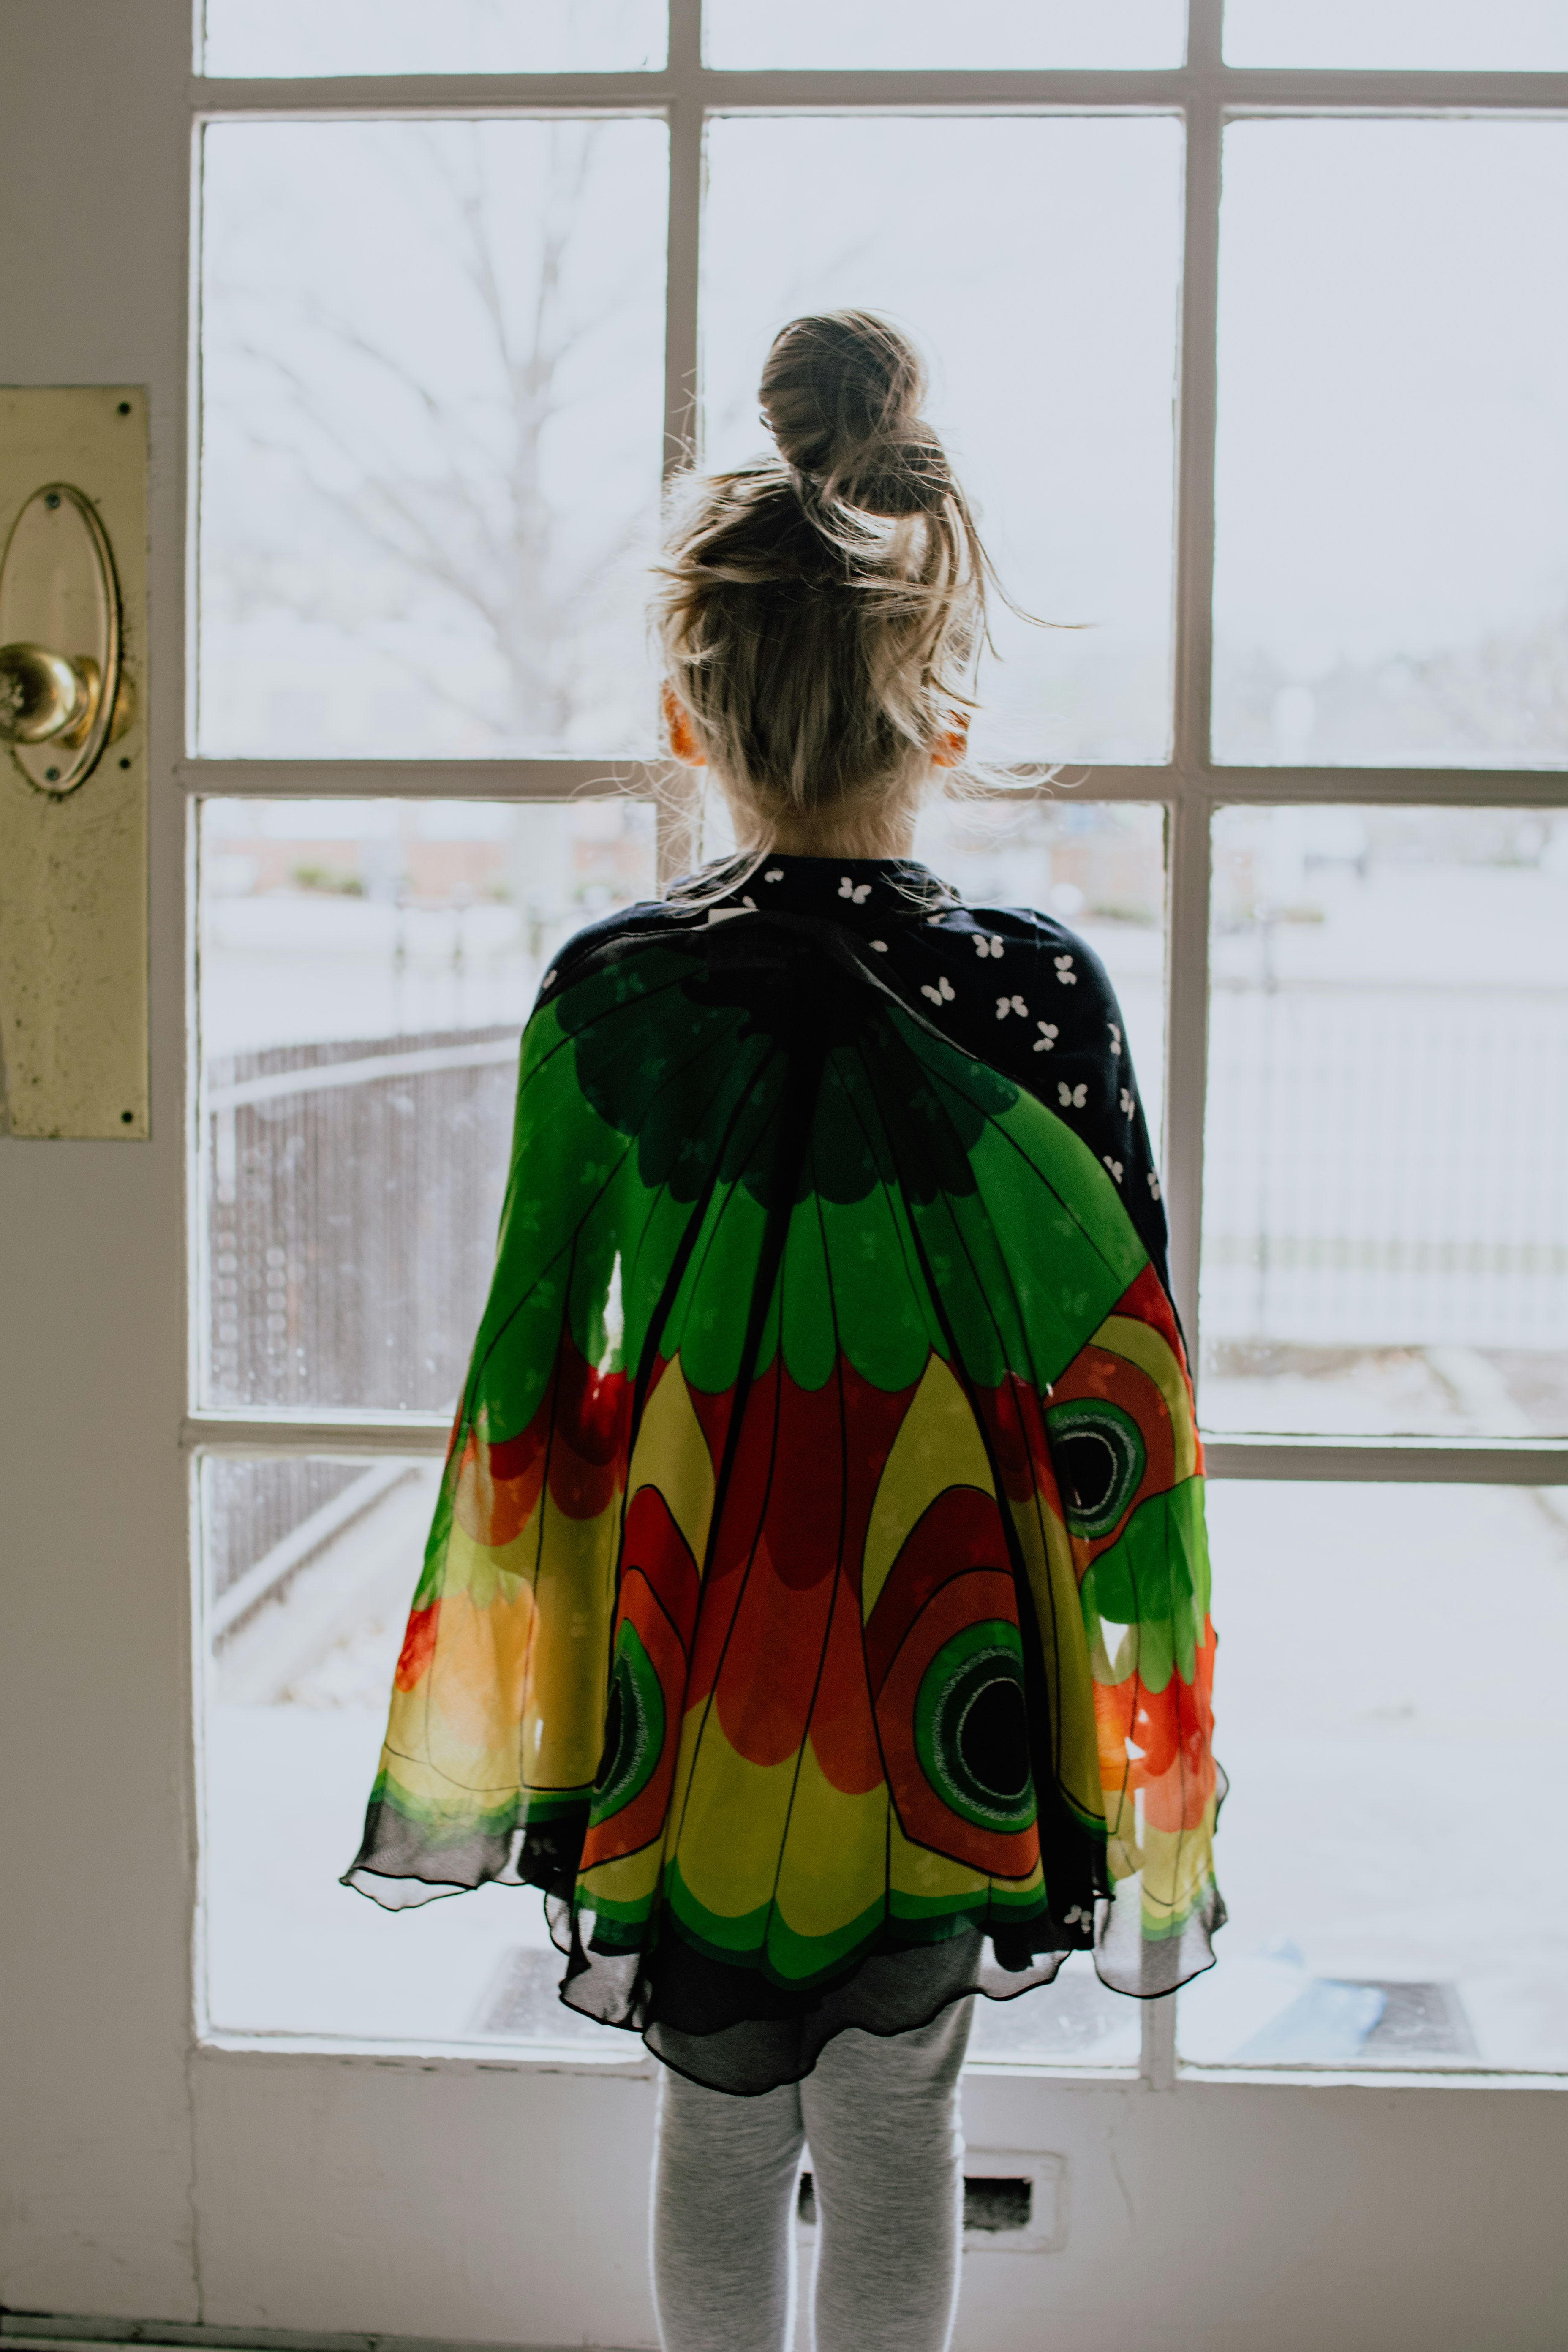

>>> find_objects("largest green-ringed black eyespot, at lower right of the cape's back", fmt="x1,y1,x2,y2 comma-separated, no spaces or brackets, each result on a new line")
915,1618,1034,1832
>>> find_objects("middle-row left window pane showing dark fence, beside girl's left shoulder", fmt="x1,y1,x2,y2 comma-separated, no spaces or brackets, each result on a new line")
200,800,653,1411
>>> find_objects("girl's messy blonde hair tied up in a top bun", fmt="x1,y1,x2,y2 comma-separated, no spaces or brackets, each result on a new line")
653,310,990,856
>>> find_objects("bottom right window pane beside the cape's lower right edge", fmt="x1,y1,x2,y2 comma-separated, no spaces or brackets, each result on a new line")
1178,1482,1568,2070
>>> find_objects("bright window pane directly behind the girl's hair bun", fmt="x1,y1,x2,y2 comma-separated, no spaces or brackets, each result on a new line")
703,117,1180,762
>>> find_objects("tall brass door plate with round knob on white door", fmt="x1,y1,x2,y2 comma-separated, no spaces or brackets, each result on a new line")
0,386,148,1141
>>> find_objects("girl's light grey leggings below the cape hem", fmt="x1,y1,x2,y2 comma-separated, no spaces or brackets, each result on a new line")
653,2001,973,2352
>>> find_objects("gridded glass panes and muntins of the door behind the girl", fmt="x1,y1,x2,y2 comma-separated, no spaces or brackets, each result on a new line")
186,0,1568,2079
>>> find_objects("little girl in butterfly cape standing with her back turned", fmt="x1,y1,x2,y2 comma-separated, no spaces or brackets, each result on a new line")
348,313,1222,2352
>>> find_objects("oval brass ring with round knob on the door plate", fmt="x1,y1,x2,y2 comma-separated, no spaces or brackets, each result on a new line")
0,482,136,795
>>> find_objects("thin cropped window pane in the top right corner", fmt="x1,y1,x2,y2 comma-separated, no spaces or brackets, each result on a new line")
1225,0,1568,73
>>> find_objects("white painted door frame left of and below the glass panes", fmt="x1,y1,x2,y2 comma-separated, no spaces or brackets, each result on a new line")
0,0,1568,2352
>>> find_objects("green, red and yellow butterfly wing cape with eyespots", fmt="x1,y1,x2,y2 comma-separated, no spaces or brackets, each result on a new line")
348,915,1222,2088
